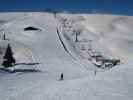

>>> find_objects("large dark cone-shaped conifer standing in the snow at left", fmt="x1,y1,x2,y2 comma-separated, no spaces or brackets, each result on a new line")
2,44,15,68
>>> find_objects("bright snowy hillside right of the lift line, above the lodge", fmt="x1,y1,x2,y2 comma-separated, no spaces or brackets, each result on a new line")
56,14,133,63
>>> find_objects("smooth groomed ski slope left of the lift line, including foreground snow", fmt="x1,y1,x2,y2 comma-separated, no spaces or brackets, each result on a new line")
0,13,133,100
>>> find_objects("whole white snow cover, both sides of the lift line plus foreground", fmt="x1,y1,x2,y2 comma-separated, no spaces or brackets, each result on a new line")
0,12,133,100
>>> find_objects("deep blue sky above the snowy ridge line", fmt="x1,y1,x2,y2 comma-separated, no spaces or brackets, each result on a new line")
0,0,133,15
